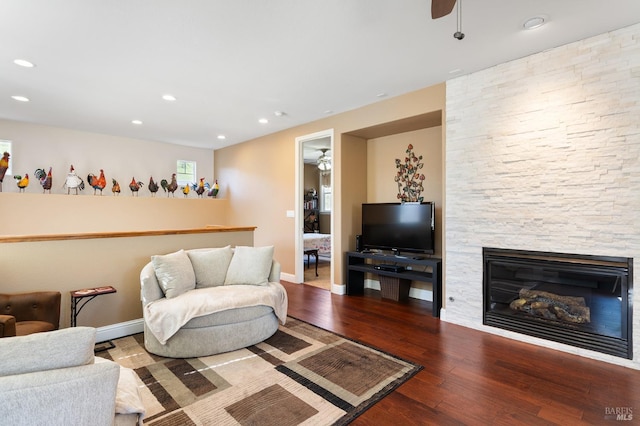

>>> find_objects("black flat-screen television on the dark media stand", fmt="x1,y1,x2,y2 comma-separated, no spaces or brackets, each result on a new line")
361,202,435,255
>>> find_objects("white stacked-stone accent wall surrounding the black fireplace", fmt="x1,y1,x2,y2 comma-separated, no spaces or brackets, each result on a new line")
443,25,640,368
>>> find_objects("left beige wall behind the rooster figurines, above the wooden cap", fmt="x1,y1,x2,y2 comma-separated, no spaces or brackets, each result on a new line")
0,120,229,236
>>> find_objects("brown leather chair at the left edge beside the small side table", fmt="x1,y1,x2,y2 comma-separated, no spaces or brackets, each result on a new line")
0,291,61,337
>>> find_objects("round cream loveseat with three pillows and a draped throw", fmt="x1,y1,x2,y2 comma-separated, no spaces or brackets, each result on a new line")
140,246,288,358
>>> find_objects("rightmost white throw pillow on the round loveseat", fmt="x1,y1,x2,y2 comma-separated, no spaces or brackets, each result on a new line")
224,246,273,285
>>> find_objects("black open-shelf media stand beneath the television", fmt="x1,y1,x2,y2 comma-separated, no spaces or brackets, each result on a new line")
347,251,442,317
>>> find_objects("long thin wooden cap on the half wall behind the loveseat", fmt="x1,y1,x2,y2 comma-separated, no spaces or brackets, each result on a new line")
0,225,256,243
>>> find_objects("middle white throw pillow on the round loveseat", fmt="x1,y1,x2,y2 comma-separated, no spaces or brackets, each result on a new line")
187,246,233,288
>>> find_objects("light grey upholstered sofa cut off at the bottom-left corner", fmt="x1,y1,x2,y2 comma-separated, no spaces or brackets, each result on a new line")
0,327,144,426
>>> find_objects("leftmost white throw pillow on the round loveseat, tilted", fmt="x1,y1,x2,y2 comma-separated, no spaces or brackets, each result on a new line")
151,250,196,299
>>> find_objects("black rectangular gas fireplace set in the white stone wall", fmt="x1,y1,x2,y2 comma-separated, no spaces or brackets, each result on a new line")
483,247,633,359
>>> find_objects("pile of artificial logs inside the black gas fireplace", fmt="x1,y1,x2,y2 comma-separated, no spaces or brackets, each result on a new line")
509,288,591,324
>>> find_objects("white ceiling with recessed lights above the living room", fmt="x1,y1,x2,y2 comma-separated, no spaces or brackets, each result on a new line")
0,0,640,149
